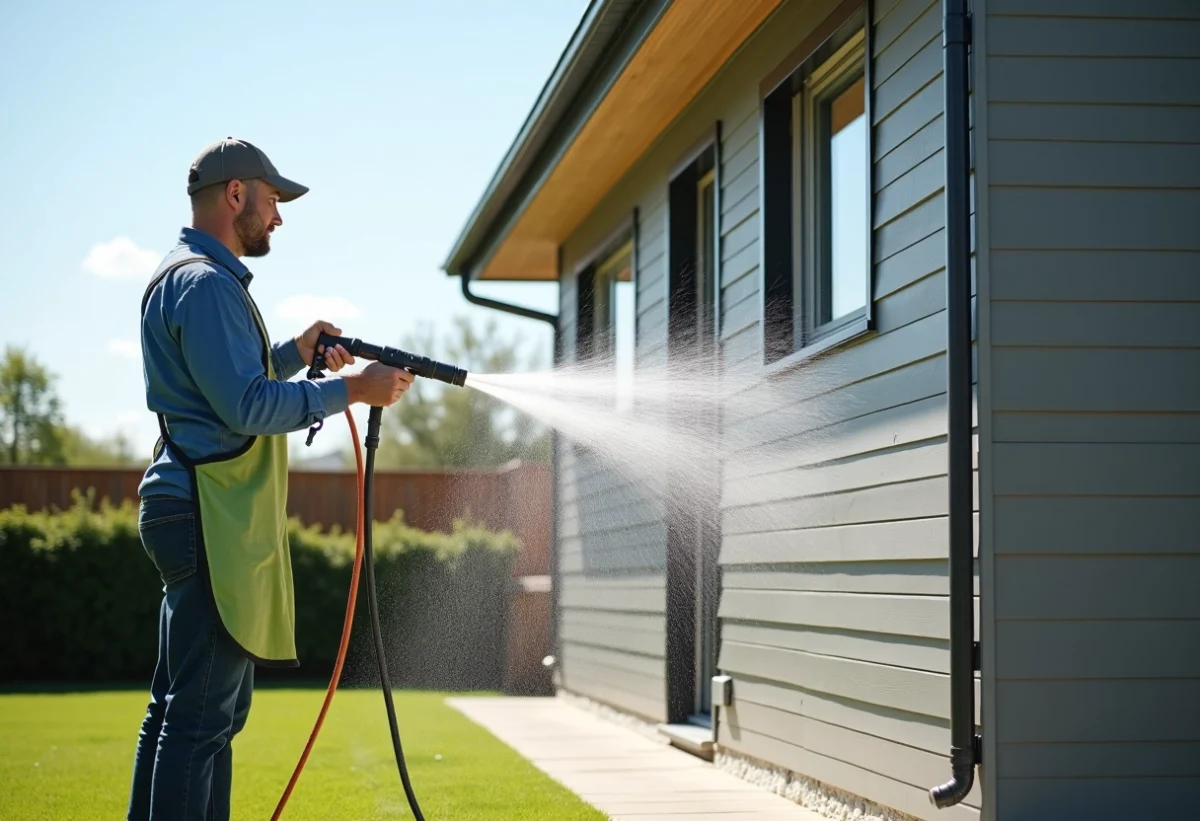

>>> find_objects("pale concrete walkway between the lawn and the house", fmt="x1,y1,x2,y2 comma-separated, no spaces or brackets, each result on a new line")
448,697,823,821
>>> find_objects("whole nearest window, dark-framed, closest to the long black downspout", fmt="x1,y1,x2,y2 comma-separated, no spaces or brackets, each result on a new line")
763,8,871,361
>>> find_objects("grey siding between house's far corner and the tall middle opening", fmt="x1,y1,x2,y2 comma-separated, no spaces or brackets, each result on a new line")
558,171,666,721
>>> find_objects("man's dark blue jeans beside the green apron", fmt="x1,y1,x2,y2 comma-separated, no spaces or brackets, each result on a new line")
126,497,254,821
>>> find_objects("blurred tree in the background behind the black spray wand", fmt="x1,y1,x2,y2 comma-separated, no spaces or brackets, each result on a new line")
369,317,550,467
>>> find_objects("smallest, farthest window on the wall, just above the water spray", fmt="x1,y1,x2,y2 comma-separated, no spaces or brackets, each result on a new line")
576,233,636,411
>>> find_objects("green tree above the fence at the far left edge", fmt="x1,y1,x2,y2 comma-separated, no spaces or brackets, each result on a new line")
0,346,66,465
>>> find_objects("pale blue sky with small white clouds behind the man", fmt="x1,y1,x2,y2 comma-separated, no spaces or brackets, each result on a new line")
0,0,587,454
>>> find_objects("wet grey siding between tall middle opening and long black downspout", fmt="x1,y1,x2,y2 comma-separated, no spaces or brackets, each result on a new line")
719,0,982,820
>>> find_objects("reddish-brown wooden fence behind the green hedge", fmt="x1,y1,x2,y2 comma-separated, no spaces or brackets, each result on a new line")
0,462,553,695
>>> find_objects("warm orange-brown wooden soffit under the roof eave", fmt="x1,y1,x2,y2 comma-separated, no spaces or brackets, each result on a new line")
479,0,781,281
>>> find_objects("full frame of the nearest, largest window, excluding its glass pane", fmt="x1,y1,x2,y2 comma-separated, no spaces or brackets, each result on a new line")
758,0,876,374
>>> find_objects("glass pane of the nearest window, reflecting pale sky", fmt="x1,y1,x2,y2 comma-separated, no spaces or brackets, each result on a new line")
822,79,868,322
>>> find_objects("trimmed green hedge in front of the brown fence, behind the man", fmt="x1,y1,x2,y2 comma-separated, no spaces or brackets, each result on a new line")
0,495,518,689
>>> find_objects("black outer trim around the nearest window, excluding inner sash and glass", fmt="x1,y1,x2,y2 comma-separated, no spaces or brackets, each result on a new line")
758,0,876,372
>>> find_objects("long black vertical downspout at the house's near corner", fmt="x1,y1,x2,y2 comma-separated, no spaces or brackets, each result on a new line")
929,0,980,808
